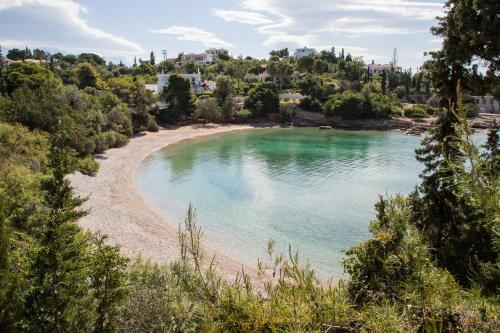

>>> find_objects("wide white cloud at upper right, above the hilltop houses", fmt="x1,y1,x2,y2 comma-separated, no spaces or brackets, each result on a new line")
236,0,444,46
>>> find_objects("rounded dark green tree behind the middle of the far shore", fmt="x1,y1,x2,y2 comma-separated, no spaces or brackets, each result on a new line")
245,82,280,117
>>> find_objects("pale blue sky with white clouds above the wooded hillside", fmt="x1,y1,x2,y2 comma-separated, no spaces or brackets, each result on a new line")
0,0,444,69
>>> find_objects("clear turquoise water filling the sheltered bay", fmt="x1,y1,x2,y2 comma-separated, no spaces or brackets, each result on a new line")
136,129,421,279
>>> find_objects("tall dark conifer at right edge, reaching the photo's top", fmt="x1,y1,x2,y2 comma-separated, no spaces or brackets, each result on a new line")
413,0,500,285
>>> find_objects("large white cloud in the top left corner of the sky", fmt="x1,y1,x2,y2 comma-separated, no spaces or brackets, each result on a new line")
0,0,144,55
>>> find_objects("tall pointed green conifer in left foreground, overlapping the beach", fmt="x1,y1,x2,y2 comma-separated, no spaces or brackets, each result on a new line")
26,125,93,332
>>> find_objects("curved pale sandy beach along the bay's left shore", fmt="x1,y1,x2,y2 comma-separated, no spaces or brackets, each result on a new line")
70,125,262,278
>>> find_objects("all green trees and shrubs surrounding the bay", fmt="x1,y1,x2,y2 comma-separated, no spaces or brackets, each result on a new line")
0,0,500,333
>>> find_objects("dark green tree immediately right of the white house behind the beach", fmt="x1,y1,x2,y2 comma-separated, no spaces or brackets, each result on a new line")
159,75,195,122
